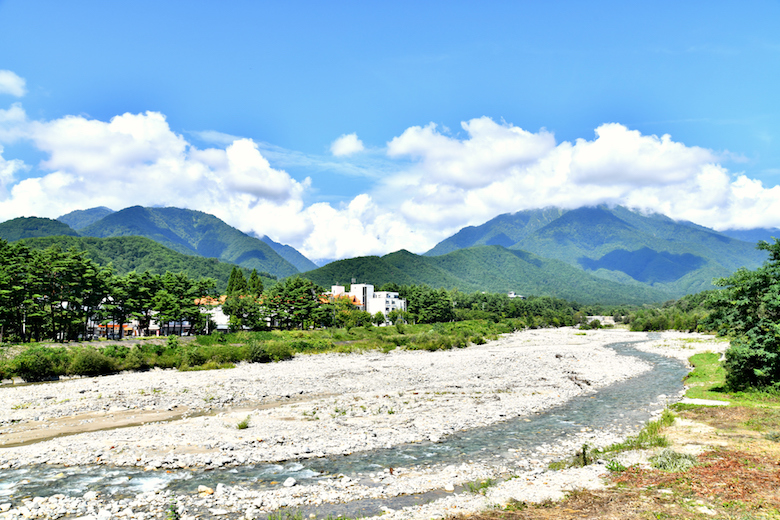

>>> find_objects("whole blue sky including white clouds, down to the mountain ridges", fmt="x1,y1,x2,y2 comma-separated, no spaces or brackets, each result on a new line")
0,0,780,258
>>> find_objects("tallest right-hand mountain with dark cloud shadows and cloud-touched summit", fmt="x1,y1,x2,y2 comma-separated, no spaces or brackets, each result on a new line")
426,206,766,297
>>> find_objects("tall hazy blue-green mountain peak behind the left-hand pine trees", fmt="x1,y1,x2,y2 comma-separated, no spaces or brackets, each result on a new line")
80,206,298,277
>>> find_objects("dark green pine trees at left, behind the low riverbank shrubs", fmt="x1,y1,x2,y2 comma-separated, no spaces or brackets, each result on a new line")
0,240,222,342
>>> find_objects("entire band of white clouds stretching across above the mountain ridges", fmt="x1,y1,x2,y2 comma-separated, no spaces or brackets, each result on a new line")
0,71,780,258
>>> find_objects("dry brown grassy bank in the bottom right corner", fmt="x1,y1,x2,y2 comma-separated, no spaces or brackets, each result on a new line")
453,407,780,520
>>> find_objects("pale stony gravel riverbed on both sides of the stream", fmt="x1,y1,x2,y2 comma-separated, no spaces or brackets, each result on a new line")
0,328,727,519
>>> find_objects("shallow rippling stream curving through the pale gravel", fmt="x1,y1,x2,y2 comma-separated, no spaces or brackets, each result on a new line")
0,336,687,501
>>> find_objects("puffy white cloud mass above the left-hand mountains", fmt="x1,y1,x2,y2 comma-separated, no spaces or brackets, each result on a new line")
0,107,310,234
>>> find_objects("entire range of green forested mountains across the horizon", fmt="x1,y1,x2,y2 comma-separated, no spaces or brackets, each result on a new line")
0,206,778,303
